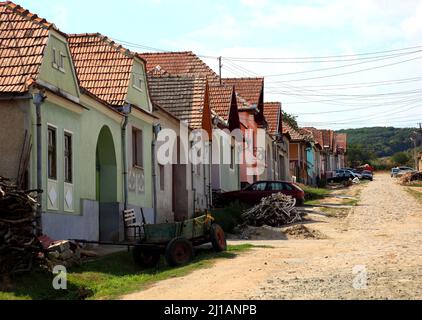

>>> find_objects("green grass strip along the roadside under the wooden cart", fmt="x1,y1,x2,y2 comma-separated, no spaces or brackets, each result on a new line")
0,245,253,300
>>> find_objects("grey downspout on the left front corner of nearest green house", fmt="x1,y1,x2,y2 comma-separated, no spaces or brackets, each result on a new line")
32,91,46,236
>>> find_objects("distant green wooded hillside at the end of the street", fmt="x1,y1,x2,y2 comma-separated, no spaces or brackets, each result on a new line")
337,127,415,158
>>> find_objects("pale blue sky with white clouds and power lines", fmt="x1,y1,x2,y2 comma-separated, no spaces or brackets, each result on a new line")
14,0,422,129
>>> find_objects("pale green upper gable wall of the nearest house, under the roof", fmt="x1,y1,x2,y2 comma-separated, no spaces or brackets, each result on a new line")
39,31,80,97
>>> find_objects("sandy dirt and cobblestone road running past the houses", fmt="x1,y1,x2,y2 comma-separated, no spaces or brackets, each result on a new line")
123,175,422,300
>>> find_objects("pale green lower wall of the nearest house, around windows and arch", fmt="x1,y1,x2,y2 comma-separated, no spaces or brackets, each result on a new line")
31,98,123,214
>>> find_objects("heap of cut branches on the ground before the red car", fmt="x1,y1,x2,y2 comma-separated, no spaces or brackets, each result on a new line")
242,193,302,227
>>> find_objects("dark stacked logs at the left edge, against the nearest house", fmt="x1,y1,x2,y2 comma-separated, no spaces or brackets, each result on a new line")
0,177,42,278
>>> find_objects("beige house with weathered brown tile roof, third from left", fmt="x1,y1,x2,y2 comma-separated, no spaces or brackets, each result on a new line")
148,75,212,221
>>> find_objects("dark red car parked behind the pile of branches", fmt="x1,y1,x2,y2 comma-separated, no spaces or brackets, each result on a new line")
221,181,305,205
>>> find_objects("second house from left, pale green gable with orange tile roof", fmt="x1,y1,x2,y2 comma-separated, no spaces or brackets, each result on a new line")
69,33,157,239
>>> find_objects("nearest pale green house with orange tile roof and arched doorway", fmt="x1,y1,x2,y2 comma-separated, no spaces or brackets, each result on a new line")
0,2,142,240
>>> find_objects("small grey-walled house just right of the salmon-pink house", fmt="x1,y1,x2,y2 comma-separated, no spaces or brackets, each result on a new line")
263,102,291,181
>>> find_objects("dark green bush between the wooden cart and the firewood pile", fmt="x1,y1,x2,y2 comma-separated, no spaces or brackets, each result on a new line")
211,201,250,232
